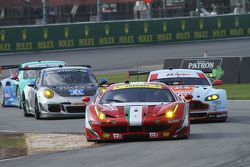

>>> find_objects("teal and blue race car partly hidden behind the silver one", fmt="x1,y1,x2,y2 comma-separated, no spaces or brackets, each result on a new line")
0,61,66,108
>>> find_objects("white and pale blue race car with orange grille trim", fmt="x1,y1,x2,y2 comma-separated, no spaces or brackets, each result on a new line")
147,69,228,121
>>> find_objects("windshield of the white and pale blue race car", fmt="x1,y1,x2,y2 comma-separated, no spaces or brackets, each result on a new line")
152,78,210,86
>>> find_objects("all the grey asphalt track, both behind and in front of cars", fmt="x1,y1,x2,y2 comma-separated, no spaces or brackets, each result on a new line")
0,39,250,167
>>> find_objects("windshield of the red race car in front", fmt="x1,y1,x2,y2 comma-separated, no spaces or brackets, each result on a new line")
100,88,175,104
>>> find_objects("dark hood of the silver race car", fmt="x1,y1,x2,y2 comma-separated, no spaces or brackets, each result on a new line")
48,84,98,97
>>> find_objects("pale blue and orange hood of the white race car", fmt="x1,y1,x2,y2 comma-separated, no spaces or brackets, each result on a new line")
170,85,214,100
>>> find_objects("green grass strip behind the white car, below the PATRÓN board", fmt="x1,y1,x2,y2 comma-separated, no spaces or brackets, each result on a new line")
96,72,250,100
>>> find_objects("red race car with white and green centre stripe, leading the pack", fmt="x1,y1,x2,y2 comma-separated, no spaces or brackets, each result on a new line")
82,82,192,141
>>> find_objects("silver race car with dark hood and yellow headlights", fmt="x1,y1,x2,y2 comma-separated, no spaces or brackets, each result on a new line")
23,66,105,119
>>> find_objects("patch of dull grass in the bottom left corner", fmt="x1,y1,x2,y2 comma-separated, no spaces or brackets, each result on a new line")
0,133,27,159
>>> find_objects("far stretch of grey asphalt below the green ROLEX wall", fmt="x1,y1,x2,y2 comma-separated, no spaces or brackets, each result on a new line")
0,38,250,71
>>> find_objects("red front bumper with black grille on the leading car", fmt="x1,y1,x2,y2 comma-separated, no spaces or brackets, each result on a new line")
86,120,190,141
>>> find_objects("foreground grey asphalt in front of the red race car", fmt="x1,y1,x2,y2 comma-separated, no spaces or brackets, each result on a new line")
0,101,250,167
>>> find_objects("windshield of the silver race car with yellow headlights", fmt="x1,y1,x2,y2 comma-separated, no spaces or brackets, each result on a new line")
43,69,97,86
